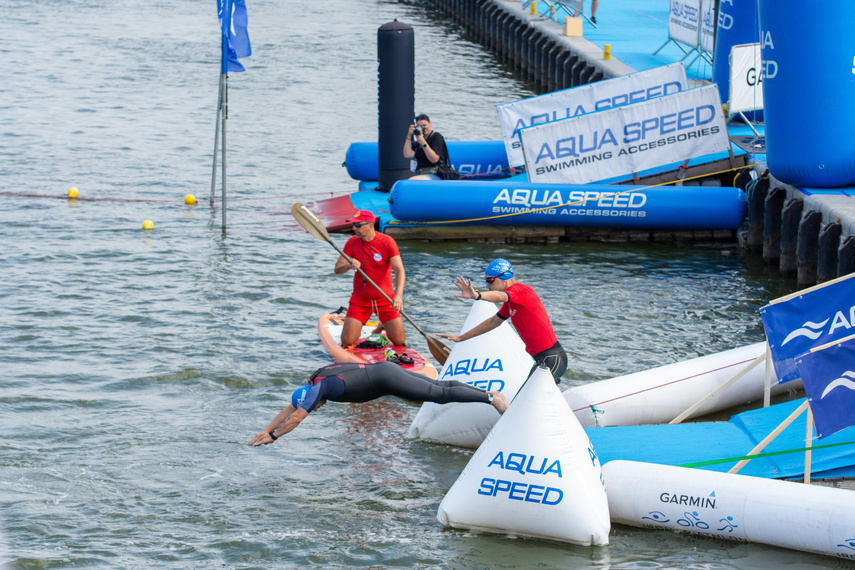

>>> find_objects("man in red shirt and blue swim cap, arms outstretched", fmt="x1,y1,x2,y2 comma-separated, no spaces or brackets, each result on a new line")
437,258,567,384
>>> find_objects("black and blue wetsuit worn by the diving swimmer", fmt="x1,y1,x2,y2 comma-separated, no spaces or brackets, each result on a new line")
300,362,492,412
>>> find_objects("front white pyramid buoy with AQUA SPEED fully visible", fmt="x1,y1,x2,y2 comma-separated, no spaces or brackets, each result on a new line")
437,368,610,546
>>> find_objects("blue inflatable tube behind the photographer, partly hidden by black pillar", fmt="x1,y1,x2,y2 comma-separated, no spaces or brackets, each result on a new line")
344,140,511,180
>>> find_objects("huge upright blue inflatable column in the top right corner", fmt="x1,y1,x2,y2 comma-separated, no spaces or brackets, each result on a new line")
760,0,855,188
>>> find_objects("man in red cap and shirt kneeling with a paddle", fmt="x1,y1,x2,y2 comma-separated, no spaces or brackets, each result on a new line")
335,210,406,346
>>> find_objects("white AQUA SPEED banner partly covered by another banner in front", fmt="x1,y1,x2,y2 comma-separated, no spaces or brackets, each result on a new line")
496,63,689,166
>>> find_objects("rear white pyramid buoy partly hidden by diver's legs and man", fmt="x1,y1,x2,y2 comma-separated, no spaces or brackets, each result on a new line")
407,301,534,449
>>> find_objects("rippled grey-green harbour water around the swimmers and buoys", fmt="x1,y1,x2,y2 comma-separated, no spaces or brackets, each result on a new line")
0,0,829,568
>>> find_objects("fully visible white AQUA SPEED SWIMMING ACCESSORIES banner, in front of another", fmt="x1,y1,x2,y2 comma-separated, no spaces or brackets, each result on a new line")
520,85,730,184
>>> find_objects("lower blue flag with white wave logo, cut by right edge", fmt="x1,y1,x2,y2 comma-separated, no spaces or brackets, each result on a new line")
796,337,855,439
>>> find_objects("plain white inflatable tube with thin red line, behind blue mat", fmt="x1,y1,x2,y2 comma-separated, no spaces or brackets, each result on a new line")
564,342,801,427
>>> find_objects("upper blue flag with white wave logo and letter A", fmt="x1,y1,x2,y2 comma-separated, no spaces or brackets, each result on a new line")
760,274,855,383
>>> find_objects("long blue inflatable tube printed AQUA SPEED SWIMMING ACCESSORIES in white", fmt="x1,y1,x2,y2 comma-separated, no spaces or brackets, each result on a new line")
390,180,747,230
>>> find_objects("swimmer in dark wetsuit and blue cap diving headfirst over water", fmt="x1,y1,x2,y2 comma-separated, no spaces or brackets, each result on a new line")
247,362,508,447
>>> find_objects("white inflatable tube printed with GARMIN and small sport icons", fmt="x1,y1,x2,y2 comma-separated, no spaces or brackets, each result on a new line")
603,461,855,560
